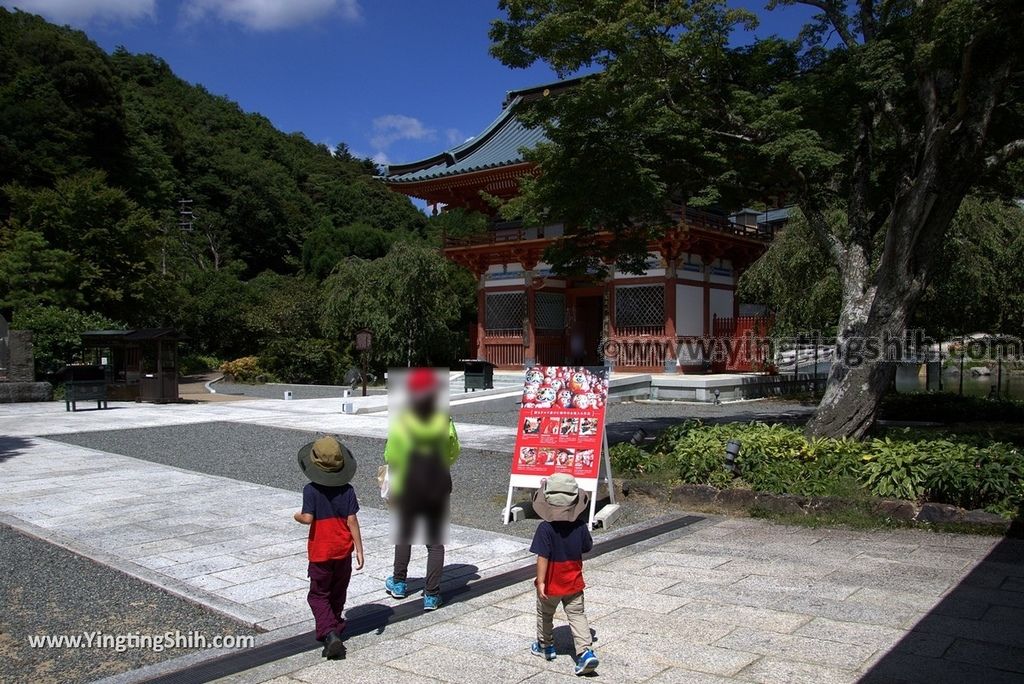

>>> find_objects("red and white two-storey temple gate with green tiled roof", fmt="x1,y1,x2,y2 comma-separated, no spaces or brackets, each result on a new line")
383,83,787,373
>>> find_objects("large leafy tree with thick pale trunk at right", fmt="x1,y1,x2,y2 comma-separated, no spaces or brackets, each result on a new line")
490,0,1024,437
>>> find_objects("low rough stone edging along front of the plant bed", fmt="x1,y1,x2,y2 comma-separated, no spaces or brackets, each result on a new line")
620,479,1010,531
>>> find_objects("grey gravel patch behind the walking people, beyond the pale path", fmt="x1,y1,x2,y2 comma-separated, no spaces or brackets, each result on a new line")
49,422,658,537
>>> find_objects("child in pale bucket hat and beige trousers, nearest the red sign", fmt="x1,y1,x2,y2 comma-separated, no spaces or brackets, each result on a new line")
529,473,598,675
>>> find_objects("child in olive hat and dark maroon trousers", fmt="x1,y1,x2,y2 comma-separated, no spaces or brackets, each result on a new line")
293,437,362,658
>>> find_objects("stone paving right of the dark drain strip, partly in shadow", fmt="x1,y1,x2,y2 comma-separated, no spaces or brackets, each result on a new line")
203,519,1024,684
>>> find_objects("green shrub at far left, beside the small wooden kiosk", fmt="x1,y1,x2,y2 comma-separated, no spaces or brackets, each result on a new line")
11,305,124,377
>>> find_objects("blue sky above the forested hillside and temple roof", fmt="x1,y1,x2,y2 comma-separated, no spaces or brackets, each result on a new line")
0,0,808,167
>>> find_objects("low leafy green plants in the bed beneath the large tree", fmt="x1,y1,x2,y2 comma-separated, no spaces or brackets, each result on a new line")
611,421,1024,513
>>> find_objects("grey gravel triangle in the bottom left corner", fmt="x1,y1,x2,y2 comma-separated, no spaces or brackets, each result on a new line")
0,524,254,684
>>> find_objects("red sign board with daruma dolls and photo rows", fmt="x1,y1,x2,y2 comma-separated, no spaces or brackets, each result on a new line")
512,366,608,478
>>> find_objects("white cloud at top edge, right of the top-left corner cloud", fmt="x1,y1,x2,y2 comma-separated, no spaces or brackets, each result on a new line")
180,0,360,31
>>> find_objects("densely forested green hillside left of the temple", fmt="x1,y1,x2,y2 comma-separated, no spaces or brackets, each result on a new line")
0,8,471,382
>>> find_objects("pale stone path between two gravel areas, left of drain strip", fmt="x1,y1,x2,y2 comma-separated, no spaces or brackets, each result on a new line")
0,438,527,630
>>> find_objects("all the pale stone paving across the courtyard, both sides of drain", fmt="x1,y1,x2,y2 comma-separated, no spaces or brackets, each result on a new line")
0,399,1024,684
